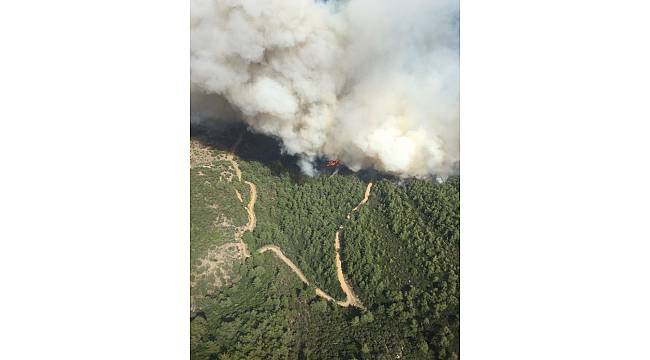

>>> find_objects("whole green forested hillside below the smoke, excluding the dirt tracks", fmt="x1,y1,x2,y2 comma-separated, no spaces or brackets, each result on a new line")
190,128,460,359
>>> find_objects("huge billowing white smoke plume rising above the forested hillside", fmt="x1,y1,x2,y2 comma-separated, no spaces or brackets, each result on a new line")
191,0,459,177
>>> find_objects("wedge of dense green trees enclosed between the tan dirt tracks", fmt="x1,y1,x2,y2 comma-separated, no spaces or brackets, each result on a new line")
242,165,365,299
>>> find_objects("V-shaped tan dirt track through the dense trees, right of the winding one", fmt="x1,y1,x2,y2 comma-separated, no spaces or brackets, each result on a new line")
257,182,372,310
